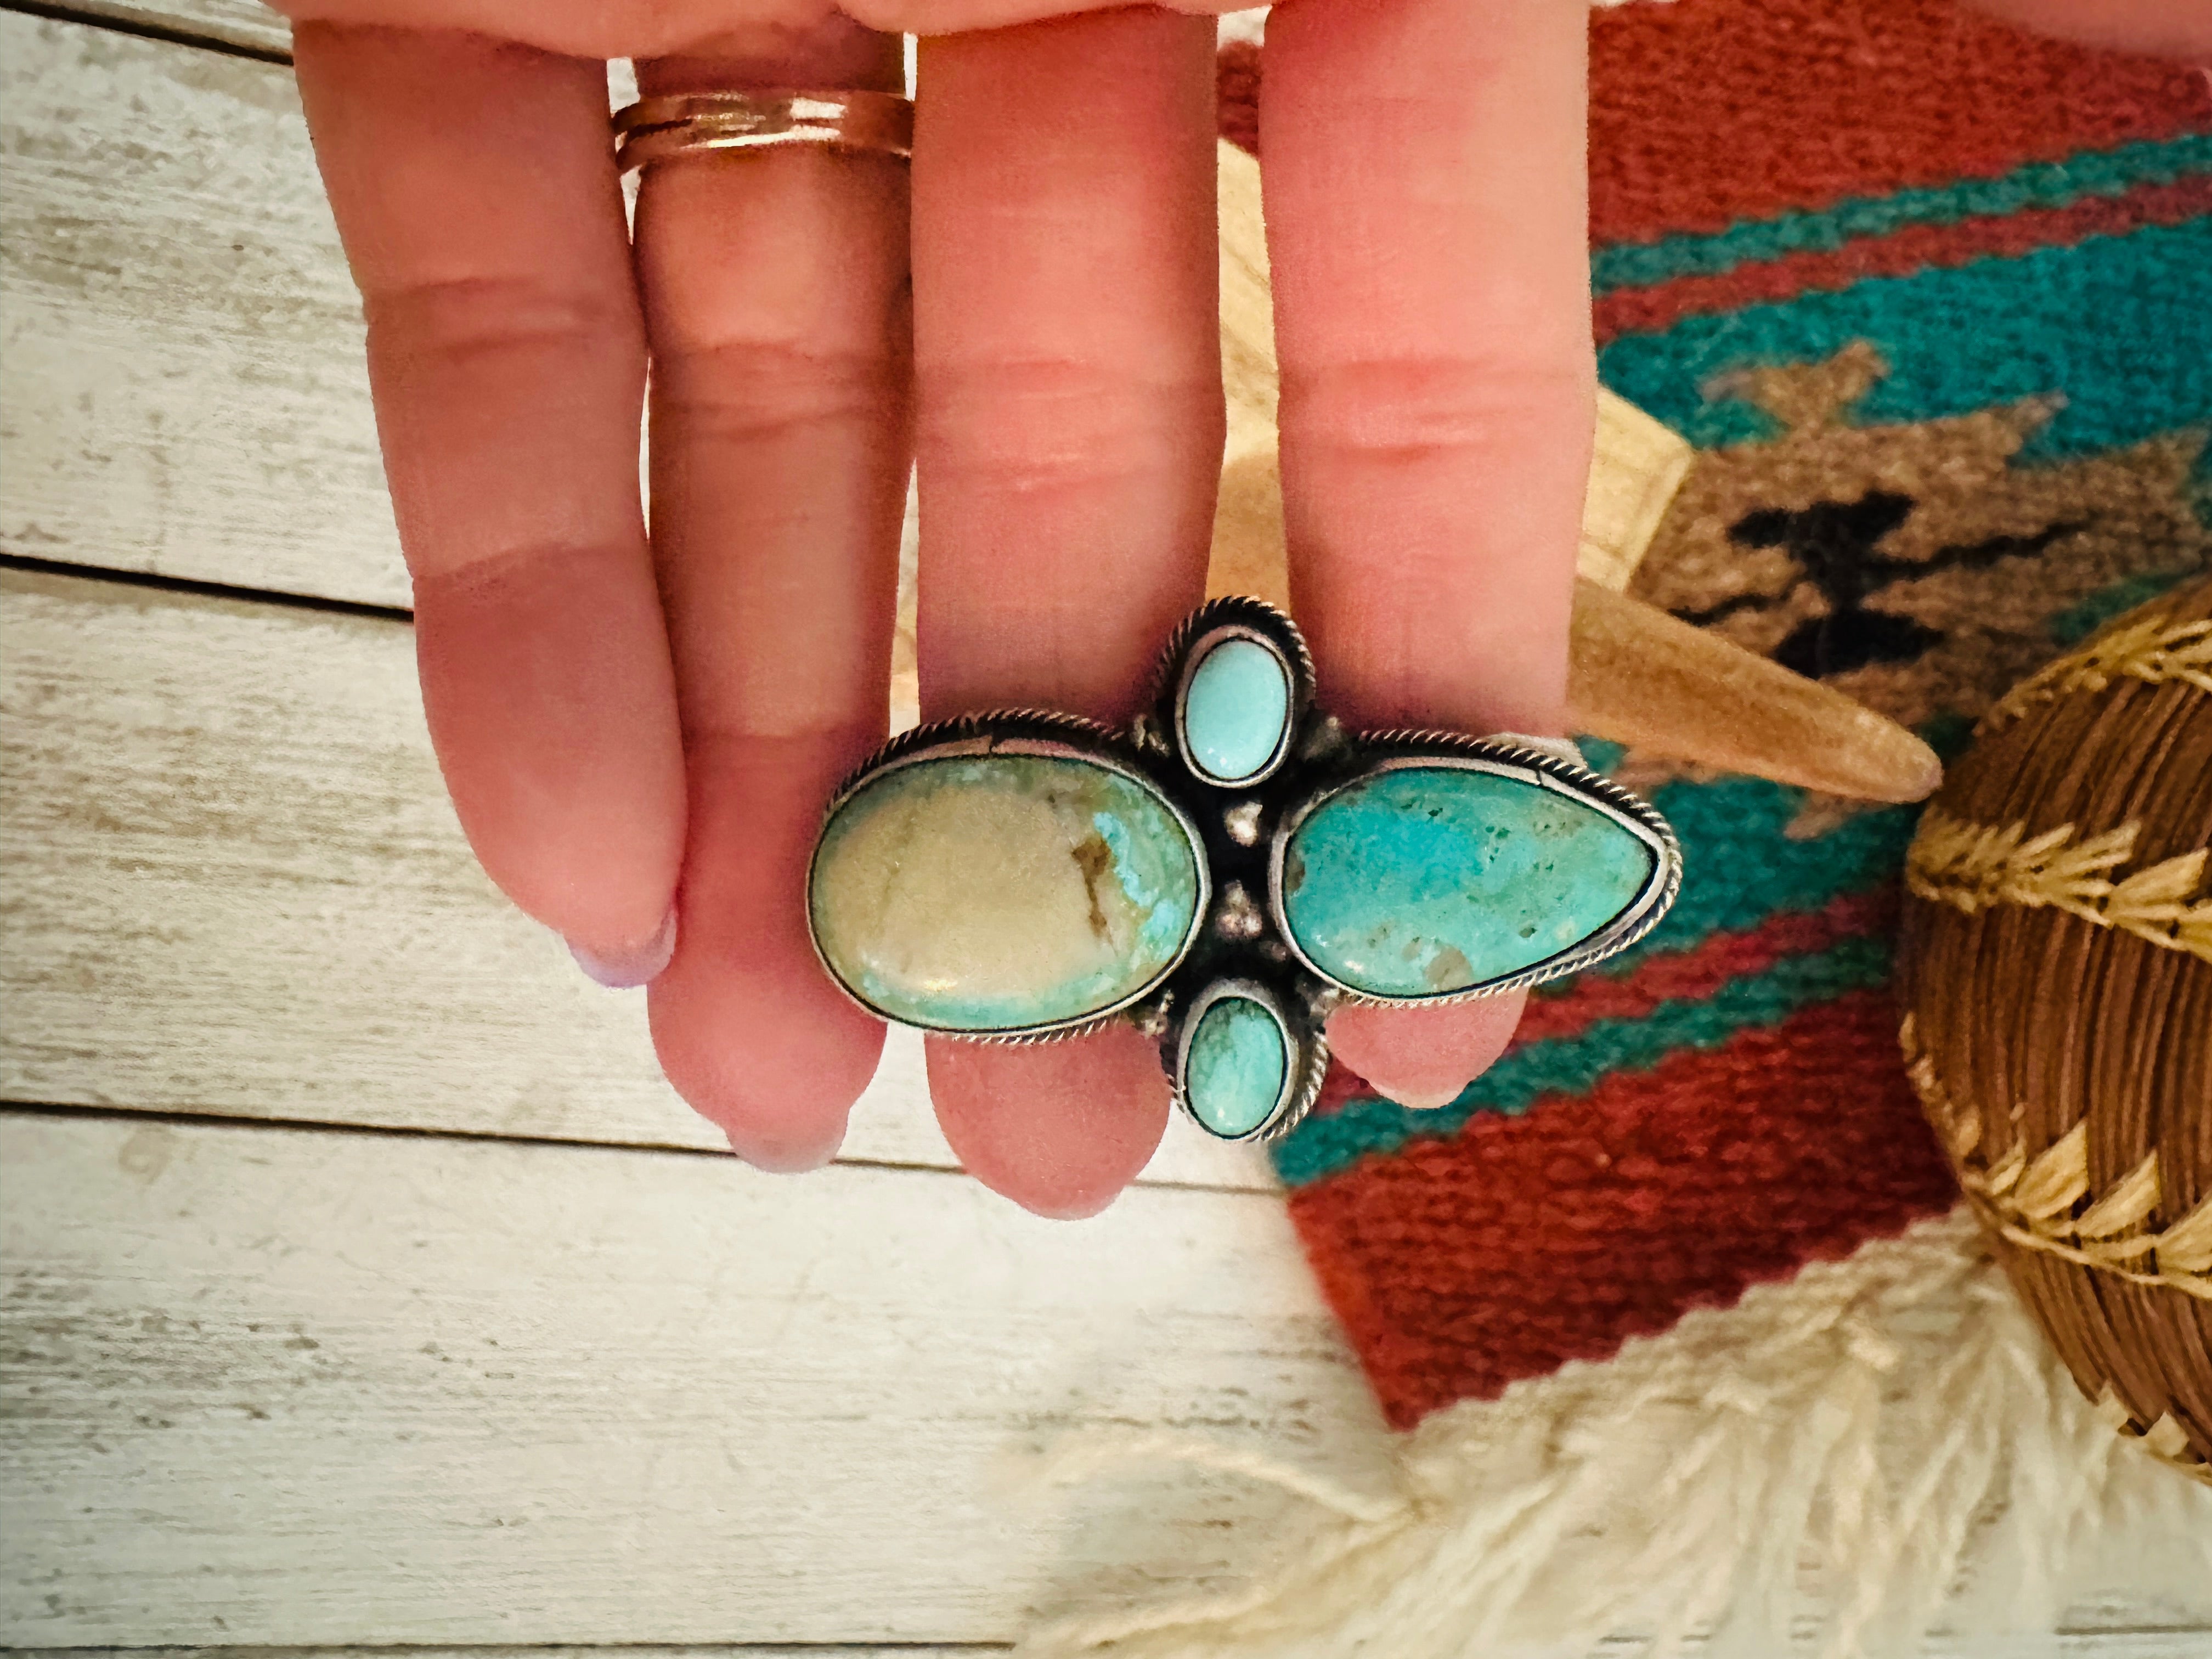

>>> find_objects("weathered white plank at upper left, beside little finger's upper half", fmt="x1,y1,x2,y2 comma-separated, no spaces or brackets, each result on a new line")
0,13,409,606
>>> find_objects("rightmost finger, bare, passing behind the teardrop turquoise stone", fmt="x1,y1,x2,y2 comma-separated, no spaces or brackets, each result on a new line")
1261,0,1595,1099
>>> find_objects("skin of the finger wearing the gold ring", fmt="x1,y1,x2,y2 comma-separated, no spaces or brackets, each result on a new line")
637,20,909,1168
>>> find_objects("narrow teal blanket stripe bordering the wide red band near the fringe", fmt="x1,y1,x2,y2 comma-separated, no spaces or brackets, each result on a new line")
1274,938,1889,1186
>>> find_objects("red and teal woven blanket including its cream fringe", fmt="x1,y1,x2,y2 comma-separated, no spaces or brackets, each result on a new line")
1026,0,2212,1659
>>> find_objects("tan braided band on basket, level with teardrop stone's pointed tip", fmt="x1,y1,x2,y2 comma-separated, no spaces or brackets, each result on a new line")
1905,808,2212,962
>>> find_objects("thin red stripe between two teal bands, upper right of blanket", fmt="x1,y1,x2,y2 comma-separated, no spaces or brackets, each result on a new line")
1595,177,2212,343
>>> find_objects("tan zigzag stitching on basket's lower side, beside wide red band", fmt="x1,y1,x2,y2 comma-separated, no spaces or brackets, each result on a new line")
1898,1015,2212,1301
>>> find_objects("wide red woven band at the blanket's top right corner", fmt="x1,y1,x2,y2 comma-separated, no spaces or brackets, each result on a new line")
1590,0,2212,246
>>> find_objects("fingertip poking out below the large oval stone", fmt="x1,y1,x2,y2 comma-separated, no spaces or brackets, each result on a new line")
929,1026,1168,1221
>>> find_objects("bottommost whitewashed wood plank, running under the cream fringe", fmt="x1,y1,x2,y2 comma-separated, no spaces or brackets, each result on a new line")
0,1113,1385,1646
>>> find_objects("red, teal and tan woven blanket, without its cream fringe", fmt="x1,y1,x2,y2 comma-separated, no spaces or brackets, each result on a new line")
1276,0,2212,1427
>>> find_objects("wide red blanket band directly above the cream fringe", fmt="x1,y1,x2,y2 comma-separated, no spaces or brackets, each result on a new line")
1290,993,1957,1429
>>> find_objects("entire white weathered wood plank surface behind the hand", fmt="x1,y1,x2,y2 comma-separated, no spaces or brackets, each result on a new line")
0,0,2212,1659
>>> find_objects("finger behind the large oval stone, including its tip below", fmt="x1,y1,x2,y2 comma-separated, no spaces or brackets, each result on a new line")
913,9,1221,1215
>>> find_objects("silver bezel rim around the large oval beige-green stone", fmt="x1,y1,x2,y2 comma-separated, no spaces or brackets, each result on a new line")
808,708,1215,1046
